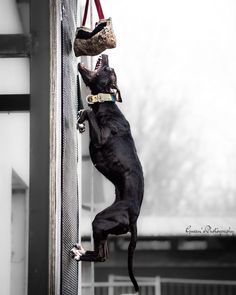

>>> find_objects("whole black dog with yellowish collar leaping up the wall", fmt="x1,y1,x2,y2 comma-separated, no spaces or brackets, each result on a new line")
71,55,144,292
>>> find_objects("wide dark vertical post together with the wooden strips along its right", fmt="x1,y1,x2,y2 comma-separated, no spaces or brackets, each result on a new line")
28,0,61,295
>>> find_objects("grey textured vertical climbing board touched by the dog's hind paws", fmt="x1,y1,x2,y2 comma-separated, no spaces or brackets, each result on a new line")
61,0,79,295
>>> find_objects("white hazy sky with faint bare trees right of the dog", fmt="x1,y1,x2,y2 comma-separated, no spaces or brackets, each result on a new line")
83,0,236,232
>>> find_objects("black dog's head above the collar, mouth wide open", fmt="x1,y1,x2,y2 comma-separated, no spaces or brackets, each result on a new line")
78,54,122,102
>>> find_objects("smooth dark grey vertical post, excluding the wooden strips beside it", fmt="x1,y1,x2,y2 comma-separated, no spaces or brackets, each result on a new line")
28,0,50,295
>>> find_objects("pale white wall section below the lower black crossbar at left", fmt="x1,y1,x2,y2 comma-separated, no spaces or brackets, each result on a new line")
0,113,29,295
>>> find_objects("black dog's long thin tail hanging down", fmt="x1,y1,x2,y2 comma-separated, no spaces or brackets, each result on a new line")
128,223,139,294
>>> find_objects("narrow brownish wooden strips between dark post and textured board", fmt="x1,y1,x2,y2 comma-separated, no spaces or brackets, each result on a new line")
49,0,61,295
